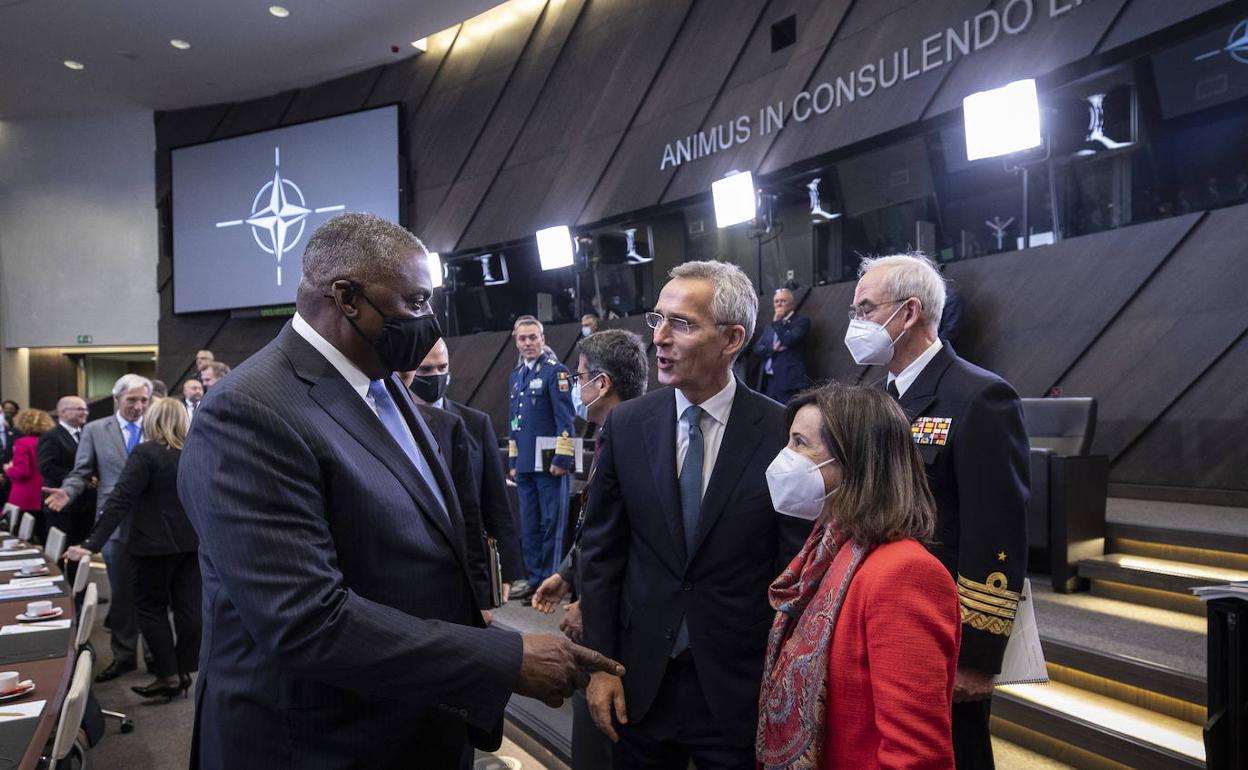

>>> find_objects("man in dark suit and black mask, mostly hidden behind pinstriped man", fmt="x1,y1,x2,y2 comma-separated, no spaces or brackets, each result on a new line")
408,339,524,602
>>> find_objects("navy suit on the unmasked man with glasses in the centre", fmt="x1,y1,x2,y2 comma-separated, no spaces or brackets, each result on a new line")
580,382,811,760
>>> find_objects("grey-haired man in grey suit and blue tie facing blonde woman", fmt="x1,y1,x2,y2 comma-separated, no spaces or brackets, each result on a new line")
46,374,152,681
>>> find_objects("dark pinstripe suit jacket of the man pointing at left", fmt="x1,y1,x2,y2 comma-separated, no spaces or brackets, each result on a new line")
178,324,522,770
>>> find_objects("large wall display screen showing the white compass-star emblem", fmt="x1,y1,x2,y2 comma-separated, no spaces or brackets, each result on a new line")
171,106,398,313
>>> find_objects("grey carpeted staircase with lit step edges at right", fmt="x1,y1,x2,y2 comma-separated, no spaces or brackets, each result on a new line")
992,499,1248,770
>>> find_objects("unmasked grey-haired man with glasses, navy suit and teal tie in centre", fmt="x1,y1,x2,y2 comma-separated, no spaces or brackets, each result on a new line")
582,262,811,769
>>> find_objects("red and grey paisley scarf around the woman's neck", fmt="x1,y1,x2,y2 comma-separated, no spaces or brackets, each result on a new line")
755,524,870,770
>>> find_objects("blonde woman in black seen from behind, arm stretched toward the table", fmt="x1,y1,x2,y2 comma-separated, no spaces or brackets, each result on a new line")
66,398,201,699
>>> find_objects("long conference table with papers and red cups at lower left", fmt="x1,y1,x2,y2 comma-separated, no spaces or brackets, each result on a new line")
0,544,77,770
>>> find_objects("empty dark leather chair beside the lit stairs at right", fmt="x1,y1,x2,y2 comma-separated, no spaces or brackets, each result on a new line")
1022,398,1109,593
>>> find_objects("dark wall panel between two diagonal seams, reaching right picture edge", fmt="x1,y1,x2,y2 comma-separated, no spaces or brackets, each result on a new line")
1060,200,1248,459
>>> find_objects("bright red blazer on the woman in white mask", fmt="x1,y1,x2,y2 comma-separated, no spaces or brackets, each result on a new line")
822,539,962,770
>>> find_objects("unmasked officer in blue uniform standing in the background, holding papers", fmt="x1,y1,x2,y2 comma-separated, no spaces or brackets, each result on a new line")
507,316,575,598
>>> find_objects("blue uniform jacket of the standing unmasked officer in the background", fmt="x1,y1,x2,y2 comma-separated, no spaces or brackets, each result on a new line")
507,353,577,473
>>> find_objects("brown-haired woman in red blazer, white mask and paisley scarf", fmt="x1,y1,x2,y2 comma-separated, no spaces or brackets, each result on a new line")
758,384,961,770
